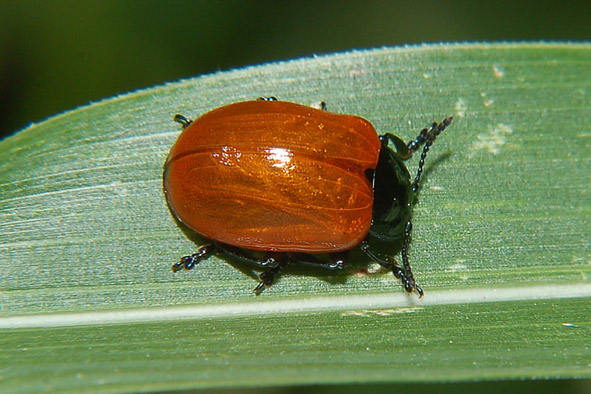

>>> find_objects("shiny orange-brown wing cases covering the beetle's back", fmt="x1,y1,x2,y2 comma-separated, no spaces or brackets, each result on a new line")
165,101,380,253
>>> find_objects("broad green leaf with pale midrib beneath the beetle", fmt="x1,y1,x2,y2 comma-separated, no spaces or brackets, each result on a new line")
0,43,591,392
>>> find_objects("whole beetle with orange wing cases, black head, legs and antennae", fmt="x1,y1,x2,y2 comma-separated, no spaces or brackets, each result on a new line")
163,97,452,297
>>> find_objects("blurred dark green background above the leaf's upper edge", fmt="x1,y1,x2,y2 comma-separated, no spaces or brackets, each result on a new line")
0,0,591,138
